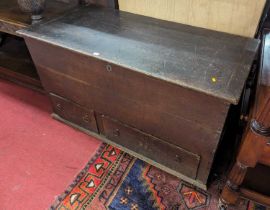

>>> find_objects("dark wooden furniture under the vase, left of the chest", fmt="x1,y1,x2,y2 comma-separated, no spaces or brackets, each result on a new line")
0,0,78,91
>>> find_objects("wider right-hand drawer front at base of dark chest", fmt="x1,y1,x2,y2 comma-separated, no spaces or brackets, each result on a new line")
99,115,200,179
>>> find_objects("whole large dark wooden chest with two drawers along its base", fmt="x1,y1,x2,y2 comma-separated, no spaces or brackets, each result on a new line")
19,7,258,188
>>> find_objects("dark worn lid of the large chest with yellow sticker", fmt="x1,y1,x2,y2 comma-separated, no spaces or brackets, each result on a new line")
19,4,259,104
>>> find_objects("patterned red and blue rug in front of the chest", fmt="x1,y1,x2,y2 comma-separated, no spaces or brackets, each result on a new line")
51,144,269,210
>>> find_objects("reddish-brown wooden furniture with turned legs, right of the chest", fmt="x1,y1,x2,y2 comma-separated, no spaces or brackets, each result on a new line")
221,30,270,206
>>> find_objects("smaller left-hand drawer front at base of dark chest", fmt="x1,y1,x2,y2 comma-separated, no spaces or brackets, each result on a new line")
50,93,98,132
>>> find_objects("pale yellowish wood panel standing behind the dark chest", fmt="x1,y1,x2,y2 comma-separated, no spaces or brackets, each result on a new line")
119,0,266,37
